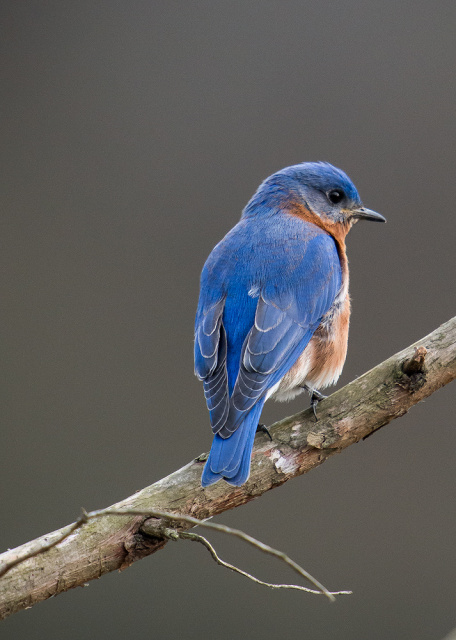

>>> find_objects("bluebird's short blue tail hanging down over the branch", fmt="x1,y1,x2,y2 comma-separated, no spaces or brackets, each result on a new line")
201,400,264,487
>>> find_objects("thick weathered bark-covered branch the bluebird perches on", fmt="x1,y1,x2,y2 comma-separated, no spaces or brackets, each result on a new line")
0,318,456,619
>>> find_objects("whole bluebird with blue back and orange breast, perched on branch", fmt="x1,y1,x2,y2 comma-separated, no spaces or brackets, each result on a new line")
194,162,386,487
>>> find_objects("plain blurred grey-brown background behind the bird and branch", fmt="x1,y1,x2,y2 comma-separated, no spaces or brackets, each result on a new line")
0,0,456,640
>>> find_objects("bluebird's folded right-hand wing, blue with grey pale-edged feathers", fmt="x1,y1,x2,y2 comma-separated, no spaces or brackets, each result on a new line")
224,234,342,438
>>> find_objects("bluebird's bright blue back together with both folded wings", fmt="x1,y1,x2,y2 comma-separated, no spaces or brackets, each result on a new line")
195,219,341,442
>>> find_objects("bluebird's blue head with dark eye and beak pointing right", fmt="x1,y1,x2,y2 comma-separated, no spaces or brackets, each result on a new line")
246,162,386,233
